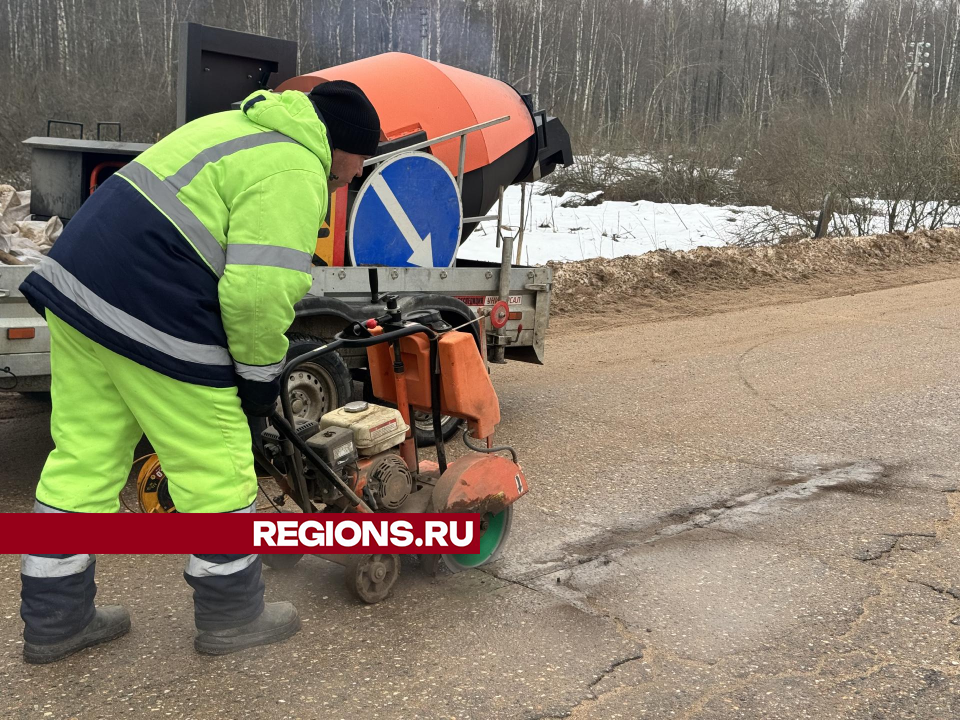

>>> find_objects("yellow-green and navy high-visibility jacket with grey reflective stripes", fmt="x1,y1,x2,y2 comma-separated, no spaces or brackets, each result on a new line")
21,91,330,394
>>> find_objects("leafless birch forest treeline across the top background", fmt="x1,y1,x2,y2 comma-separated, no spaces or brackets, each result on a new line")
0,0,960,235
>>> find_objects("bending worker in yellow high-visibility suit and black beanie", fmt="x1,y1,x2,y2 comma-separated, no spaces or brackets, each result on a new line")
20,81,380,663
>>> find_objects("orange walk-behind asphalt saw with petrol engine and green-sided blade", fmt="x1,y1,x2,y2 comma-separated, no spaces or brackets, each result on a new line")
137,295,529,603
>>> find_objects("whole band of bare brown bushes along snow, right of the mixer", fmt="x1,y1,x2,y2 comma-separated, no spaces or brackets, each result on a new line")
545,104,960,245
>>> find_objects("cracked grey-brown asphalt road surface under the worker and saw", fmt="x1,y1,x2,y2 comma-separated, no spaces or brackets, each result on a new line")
0,272,960,720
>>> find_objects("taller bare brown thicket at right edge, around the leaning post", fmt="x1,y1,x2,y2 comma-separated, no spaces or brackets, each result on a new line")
738,102,960,244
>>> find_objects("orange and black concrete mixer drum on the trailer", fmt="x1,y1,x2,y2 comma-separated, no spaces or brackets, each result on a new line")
277,53,573,241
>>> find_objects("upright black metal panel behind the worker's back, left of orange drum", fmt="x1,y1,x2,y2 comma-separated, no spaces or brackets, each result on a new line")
177,23,297,127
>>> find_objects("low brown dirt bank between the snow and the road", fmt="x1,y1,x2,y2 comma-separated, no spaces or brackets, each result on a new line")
549,228,960,313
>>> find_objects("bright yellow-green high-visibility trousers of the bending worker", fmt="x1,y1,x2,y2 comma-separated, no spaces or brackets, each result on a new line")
37,311,257,512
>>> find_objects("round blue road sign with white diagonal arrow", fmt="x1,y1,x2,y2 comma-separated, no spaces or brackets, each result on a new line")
349,152,463,267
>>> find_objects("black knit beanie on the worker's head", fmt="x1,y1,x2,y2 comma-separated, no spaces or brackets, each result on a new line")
310,80,380,155
